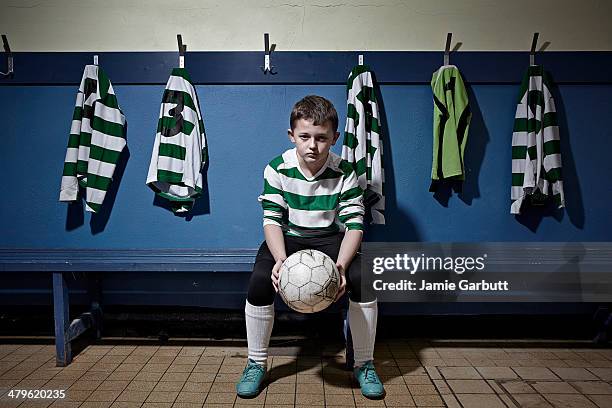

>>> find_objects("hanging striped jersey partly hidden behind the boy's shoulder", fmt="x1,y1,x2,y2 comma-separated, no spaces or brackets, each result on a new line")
342,65,385,224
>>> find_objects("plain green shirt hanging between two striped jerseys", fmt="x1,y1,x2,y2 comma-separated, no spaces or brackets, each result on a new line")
429,65,472,192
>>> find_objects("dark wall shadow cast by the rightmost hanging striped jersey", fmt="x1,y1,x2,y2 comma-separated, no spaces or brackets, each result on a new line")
516,73,585,233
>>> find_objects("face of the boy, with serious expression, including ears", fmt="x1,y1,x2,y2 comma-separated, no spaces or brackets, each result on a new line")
287,119,340,165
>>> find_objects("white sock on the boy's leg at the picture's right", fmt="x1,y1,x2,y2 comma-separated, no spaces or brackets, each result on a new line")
349,299,378,367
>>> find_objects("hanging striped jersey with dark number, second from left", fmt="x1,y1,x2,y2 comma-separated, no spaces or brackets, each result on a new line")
147,68,208,213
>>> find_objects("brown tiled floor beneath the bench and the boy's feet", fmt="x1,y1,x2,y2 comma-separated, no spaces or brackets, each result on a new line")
0,340,612,408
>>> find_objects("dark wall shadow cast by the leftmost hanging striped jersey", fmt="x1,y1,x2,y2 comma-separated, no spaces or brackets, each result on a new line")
65,122,130,235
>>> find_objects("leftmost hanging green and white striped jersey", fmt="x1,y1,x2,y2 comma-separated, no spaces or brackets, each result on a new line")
60,65,126,212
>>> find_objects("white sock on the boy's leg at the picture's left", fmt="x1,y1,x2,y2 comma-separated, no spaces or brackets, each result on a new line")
244,300,274,366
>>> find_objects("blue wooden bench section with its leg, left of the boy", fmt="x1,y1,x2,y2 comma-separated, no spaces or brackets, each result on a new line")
0,249,257,367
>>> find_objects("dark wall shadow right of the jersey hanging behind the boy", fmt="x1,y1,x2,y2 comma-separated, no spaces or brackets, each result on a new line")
364,79,420,242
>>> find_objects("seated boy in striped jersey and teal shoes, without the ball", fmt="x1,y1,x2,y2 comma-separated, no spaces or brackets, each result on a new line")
236,95,384,398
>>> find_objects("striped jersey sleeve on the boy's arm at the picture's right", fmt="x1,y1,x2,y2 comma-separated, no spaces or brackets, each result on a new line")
338,163,365,231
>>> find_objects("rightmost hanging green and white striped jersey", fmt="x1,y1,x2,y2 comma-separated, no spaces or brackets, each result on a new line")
510,65,565,214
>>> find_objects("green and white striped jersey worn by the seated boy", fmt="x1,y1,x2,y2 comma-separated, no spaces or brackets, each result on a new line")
259,148,364,237
